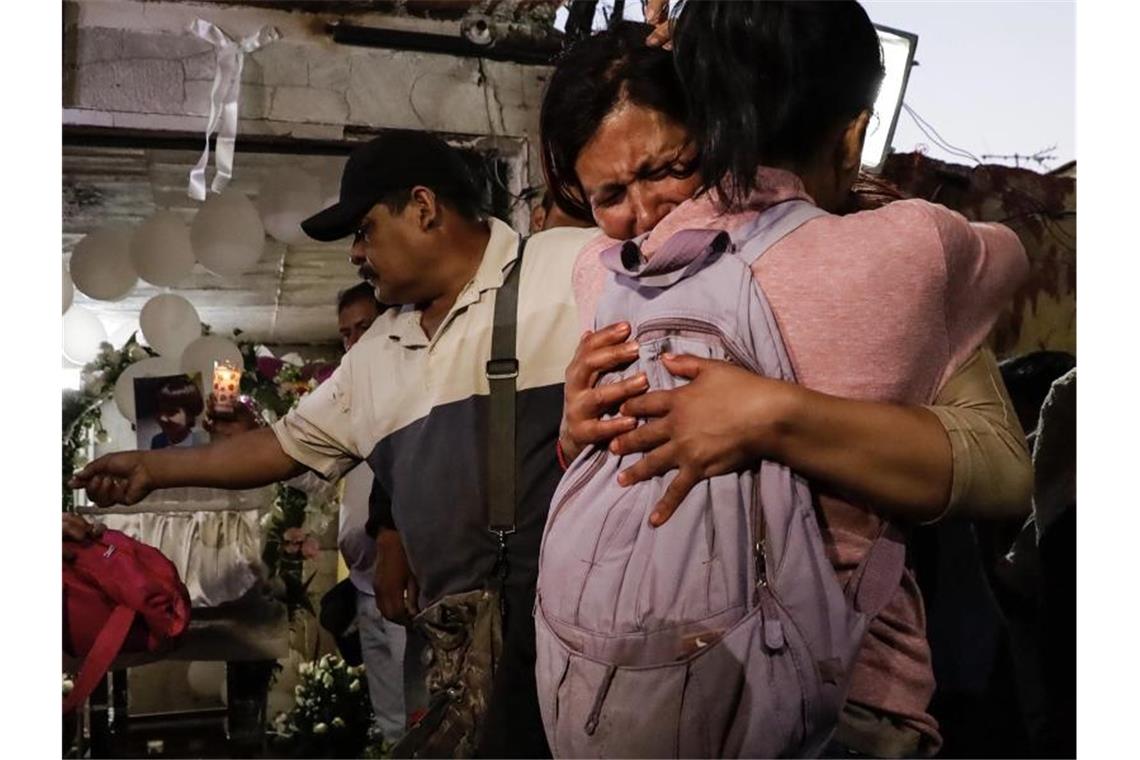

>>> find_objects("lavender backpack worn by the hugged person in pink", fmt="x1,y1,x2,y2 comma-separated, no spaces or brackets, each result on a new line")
535,201,904,758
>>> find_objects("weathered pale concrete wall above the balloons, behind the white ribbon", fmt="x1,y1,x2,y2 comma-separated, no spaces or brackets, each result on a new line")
63,0,549,229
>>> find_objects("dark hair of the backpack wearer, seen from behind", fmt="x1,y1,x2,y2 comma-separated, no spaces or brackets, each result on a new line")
673,0,884,203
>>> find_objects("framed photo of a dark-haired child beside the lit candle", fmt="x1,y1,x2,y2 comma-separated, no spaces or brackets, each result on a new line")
135,375,210,450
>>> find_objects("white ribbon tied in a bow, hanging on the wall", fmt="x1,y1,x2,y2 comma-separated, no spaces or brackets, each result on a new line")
188,18,280,201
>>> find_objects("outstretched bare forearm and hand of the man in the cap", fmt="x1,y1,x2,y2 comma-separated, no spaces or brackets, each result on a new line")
71,427,306,507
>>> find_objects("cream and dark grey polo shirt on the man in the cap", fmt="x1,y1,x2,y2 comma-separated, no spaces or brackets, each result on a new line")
274,219,597,606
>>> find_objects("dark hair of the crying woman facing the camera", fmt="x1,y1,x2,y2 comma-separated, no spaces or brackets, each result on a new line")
538,22,685,220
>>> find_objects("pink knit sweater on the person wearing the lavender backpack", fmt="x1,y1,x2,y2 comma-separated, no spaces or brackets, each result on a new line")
573,169,1028,745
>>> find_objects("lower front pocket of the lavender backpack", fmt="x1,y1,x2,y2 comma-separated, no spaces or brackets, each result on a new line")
536,588,820,758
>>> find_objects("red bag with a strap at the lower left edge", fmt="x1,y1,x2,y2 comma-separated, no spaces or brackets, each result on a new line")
64,530,190,713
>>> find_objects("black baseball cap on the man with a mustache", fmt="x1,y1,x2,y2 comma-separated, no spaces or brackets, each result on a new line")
301,131,479,242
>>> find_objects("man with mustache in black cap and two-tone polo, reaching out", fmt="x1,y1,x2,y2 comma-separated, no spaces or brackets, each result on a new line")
73,132,596,757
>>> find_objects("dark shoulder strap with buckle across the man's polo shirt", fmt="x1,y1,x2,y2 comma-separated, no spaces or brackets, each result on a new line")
487,236,527,542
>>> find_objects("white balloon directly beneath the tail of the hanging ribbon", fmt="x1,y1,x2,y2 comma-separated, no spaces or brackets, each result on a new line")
190,190,266,277
